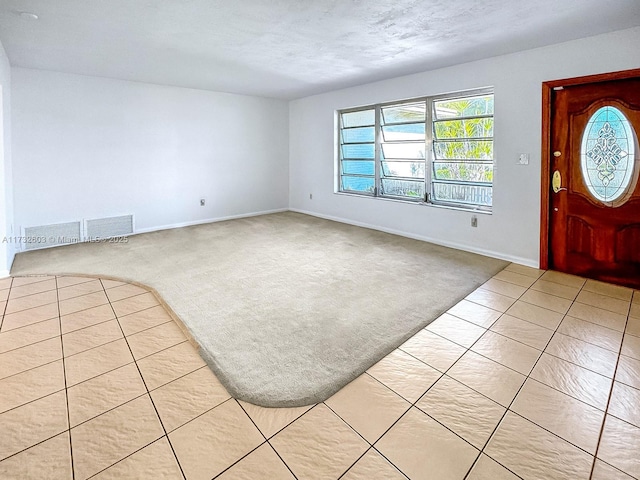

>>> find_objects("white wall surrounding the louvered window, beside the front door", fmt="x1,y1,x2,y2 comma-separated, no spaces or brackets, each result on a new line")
289,28,640,266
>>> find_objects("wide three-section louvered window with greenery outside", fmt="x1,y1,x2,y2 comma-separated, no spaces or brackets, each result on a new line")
338,90,493,210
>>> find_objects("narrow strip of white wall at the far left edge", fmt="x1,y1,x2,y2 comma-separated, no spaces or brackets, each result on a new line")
0,43,15,277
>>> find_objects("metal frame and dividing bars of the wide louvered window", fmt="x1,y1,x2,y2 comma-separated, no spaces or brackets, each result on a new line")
334,87,496,213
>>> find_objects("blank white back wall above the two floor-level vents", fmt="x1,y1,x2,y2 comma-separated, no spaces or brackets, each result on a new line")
12,68,288,240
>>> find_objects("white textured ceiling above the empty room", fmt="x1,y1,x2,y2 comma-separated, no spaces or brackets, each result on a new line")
0,0,640,99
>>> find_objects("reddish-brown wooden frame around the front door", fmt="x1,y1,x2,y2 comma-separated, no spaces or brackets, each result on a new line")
540,68,640,270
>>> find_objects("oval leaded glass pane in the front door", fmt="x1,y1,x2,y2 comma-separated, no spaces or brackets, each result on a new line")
580,106,635,205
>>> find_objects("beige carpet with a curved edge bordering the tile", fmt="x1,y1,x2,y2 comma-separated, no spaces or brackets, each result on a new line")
11,212,507,407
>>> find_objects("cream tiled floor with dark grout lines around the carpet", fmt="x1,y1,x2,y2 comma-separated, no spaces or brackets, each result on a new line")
0,265,640,480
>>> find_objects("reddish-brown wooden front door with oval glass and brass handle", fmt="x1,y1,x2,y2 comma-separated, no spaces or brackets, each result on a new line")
549,77,640,288
